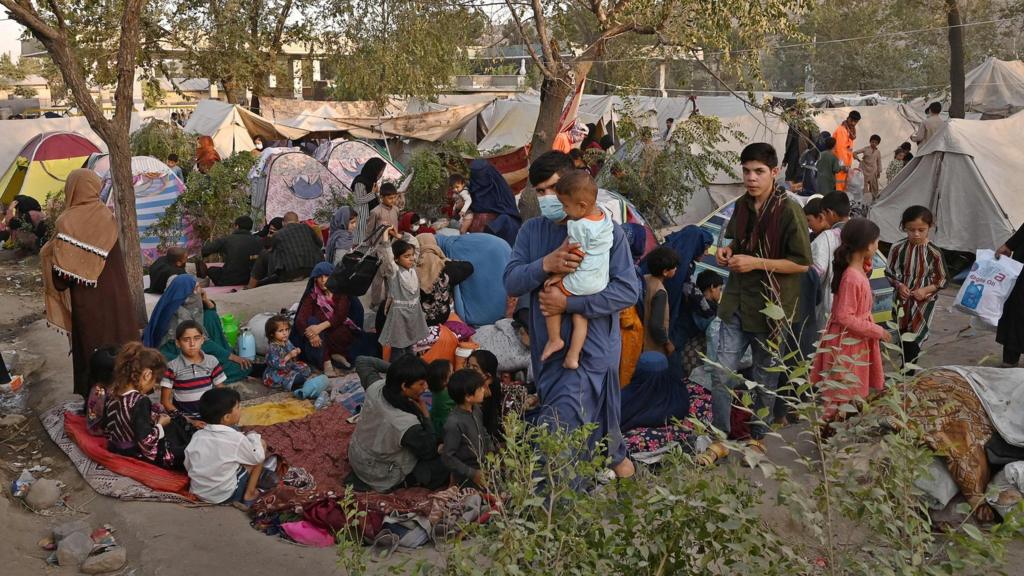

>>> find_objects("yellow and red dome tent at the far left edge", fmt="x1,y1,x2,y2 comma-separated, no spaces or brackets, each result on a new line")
0,132,99,202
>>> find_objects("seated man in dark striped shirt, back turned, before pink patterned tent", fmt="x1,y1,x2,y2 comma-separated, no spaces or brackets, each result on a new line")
249,212,324,288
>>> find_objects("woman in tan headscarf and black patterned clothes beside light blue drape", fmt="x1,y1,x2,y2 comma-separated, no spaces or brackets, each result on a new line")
416,234,473,326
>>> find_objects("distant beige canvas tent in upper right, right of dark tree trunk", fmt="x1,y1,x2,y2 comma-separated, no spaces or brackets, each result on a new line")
964,56,1024,120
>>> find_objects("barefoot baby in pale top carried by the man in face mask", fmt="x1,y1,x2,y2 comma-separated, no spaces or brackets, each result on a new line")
541,170,613,370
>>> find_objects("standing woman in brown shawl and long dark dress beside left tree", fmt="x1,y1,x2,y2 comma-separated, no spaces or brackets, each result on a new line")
40,168,139,397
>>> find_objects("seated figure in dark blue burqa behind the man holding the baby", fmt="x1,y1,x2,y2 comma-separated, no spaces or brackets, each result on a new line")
620,352,690,431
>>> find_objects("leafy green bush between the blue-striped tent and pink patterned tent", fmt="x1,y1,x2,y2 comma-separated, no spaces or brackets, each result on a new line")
152,152,256,249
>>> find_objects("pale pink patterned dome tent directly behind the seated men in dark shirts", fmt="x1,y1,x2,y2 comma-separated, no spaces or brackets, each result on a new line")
251,152,349,220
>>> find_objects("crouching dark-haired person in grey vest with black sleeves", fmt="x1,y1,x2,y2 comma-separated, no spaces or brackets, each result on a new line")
348,355,451,492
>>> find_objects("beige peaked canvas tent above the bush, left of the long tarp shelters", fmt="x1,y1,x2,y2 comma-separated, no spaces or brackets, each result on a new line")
185,100,308,158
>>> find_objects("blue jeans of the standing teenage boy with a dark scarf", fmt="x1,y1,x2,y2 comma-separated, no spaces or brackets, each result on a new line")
711,315,778,440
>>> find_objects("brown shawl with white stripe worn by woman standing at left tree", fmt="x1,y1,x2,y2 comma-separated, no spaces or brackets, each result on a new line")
40,168,118,332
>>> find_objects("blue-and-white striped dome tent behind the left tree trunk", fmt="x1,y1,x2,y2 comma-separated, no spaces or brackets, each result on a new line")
89,154,187,261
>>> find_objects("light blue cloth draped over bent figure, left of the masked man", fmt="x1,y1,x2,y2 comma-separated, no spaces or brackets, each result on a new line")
437,234,512,326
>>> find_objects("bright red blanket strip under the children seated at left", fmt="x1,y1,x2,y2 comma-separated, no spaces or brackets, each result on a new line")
65,412,196,500
